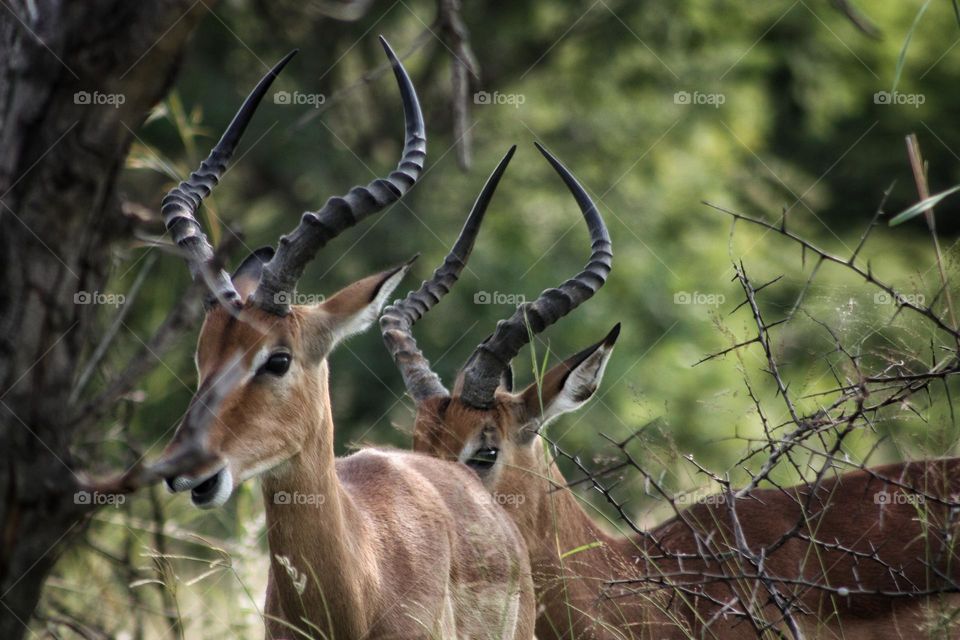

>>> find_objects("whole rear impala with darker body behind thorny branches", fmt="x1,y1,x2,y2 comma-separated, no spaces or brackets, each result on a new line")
380,142,960,640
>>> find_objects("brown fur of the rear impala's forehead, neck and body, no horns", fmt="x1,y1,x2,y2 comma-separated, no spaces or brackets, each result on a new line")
414,392,960,640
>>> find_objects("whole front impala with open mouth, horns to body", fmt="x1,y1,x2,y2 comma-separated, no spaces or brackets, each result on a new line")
158,41,534,640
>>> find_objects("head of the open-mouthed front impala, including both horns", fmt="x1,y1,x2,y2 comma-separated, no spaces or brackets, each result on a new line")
147,38,426,507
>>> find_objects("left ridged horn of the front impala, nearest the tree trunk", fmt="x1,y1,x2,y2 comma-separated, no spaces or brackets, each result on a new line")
160,50,297,304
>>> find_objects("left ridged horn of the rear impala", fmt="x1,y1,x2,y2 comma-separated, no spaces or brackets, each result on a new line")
380,145,517,404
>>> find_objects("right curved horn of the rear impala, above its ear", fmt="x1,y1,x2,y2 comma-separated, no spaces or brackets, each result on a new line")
458,143,613,409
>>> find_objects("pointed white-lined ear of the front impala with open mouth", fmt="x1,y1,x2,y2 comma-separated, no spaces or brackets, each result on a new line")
318,260,413,348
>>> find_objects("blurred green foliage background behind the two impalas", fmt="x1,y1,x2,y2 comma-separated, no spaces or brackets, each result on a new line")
44,0,960,637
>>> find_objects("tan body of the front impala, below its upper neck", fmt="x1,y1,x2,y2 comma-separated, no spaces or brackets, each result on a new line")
263,408,533,638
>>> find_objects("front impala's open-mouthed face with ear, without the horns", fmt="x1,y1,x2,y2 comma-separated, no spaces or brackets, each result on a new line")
165,260,407,508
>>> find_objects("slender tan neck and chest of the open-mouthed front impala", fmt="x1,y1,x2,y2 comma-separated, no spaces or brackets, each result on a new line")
262,361,373,638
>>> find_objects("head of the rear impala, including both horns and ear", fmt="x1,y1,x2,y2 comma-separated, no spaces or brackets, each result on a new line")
380,144,620,513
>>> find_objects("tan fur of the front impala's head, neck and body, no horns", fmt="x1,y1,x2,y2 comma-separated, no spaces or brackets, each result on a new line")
162,274,534,639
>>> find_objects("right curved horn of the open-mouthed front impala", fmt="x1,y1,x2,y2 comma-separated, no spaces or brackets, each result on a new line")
253,36,427,316
